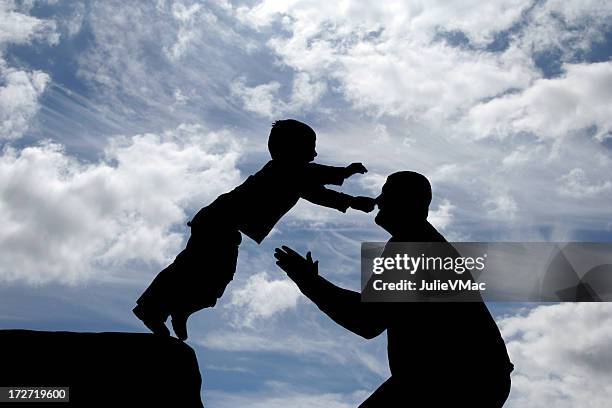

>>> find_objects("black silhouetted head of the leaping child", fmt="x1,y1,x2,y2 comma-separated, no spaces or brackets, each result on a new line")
268,119,317,163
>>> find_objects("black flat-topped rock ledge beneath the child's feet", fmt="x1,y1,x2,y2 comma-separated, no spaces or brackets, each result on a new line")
0,330,202,407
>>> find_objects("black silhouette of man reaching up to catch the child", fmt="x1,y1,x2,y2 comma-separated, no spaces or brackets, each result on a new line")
275,171,514,408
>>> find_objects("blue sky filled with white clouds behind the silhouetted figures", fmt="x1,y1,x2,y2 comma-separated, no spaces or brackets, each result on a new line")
0,0,612,408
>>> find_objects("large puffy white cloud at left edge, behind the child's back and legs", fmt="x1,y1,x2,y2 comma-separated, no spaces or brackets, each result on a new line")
0,125,240,283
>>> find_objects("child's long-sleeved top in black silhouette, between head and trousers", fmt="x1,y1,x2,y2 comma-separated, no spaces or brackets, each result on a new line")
190,160,352,244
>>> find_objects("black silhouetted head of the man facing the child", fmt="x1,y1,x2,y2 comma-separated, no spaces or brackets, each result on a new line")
374,171,431,235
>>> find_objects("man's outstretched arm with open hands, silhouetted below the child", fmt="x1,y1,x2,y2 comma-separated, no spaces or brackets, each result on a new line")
274,246,386,339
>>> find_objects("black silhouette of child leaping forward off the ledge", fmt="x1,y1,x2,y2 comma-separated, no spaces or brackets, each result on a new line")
133,119,374,340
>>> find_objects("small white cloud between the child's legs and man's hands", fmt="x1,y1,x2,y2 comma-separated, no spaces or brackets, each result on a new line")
226,272,301,327
